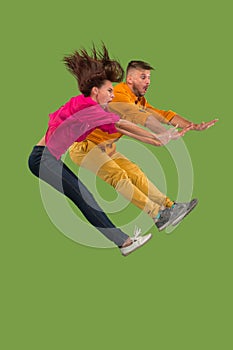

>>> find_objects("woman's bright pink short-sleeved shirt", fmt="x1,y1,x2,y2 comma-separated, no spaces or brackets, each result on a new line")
45,95,120,159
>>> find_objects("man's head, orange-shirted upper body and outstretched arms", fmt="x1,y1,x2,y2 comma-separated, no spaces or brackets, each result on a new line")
109,61,217,139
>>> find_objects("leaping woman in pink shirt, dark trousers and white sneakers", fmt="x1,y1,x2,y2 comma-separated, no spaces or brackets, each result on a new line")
28,45,155,256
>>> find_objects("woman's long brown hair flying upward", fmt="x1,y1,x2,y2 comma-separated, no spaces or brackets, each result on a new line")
63,43,124,96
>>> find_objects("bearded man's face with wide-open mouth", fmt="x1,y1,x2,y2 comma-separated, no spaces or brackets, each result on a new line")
127,69,150,97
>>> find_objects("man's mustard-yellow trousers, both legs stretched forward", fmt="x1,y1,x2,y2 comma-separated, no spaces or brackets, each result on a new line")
69,140,169,218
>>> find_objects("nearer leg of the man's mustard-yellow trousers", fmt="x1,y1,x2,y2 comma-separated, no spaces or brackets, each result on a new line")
70,140,162,218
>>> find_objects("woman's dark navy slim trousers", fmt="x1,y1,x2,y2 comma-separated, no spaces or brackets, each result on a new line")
28,146,129,247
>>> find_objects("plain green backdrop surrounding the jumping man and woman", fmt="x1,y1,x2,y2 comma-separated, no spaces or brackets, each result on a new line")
0,0,233,350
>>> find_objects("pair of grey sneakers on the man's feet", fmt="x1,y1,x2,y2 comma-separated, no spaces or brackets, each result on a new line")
155,199,198,231
